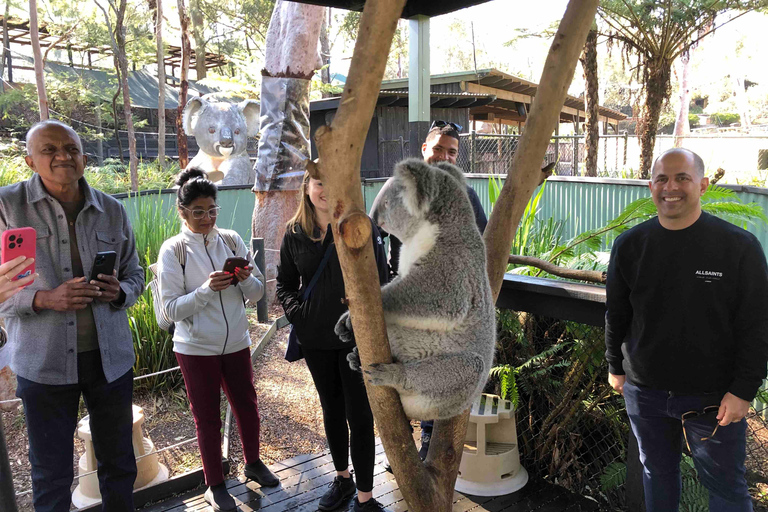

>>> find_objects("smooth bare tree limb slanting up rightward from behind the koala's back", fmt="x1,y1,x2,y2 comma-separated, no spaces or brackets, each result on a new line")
483,0,598,299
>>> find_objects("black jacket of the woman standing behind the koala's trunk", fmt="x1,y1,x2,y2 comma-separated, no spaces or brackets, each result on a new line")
277,222,388,350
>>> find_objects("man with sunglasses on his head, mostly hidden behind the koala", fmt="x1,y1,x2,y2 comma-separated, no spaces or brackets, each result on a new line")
381,120,488,460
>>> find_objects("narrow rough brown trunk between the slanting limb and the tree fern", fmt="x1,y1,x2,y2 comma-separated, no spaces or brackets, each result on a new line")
580,26,600,176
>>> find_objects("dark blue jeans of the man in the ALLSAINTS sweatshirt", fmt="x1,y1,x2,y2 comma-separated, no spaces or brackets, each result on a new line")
624,381,752,512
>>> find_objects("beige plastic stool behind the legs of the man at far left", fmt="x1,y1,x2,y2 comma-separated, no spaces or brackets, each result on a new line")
72,405,168,508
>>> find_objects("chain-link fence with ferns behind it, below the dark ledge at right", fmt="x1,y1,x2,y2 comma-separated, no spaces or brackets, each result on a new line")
491,310,768,512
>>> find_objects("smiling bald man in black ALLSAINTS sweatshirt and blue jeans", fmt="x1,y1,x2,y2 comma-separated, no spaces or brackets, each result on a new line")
605,149,768,512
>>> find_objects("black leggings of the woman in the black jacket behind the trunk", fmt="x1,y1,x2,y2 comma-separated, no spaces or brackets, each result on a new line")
302,347,376,492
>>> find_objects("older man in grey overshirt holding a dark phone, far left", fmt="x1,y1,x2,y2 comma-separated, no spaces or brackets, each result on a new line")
0,120,144,512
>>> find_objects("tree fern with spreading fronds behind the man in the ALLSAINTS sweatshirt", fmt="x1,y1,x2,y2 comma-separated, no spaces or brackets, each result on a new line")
598,0,768,178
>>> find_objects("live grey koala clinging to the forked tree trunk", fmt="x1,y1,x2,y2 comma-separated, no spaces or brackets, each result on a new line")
335,159,496,420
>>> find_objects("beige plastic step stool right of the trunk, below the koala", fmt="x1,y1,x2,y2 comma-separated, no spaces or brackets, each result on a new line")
456,393,528,496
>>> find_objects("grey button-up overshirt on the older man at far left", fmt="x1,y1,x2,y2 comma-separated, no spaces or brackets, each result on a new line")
0,173,144,385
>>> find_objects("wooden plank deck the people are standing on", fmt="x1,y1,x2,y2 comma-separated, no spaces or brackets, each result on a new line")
140,440,599,512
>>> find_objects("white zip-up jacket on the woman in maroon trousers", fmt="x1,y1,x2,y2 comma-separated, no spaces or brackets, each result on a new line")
158,225,264,356
